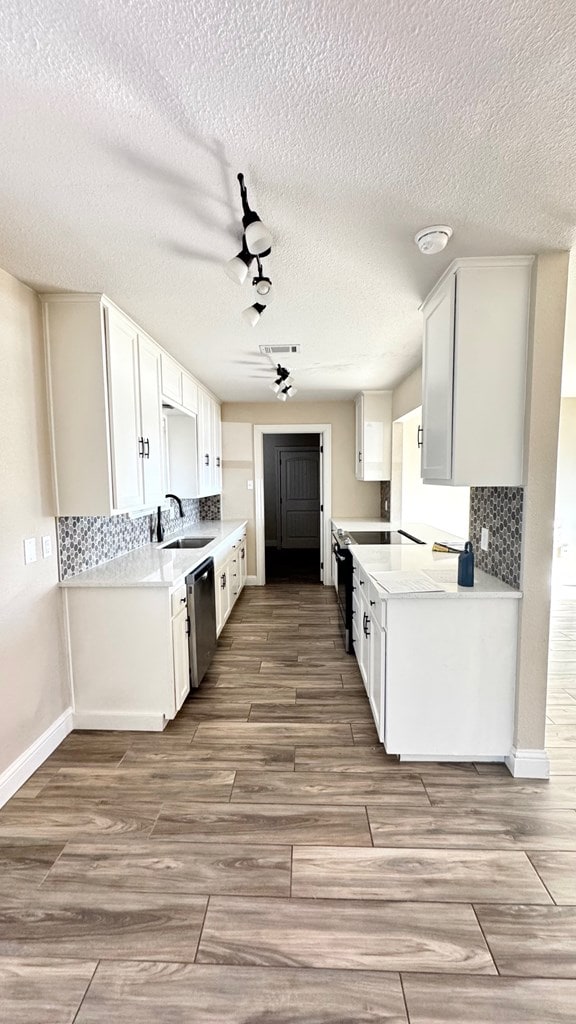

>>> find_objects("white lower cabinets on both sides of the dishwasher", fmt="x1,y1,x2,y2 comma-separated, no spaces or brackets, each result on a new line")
63,526,246,731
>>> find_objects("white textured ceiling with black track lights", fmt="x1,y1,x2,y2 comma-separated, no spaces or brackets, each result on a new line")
0,0,576,400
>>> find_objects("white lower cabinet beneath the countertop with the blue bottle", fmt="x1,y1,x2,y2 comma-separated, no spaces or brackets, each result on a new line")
353,558,519,761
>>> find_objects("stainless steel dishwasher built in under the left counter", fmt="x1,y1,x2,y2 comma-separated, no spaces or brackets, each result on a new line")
186,558,216,687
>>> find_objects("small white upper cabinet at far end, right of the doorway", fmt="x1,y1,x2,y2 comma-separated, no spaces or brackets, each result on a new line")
356,391,392,480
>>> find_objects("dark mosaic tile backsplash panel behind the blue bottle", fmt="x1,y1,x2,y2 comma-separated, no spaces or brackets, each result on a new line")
469,487,524,589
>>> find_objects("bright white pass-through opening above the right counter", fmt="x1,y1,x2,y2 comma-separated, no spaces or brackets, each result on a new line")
395,409,470,540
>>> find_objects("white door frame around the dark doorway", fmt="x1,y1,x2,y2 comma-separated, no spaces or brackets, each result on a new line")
254,423,332,587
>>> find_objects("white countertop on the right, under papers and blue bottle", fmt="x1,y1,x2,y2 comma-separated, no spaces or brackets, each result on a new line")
332,519,522,601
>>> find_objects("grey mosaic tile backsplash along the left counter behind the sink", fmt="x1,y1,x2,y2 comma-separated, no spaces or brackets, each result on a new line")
56,495,220,580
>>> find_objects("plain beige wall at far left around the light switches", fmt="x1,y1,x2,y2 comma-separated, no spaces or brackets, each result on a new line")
0,270,70,772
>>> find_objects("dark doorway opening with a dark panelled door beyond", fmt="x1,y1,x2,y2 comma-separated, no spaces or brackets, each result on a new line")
263,433,322,584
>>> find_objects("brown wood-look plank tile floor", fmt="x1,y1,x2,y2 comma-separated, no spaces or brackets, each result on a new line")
0,584,576,1024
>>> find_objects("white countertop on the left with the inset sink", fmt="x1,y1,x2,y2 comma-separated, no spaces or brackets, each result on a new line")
60,519,246,588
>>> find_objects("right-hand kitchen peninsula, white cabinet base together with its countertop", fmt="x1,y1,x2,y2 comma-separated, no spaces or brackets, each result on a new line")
332,519,522,761
